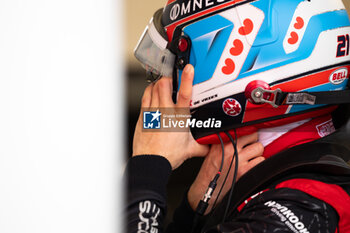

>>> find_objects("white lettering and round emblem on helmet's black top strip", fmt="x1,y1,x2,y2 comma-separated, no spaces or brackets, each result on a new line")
169,0,232,21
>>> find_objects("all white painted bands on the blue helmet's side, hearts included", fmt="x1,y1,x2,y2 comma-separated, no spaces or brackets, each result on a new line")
192,0,350,108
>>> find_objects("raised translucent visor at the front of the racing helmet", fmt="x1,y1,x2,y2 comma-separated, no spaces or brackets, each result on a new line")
134,19,175,77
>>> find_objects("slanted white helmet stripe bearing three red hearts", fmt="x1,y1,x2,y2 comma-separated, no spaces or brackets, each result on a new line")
192,4,264,104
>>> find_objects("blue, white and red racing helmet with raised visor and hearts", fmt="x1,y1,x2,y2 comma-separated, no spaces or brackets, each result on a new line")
135,0,350,144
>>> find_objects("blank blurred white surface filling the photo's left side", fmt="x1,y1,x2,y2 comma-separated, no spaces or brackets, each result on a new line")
0,0,124,233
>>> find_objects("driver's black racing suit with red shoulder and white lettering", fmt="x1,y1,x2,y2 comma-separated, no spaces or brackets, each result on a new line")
126,136,350,233
